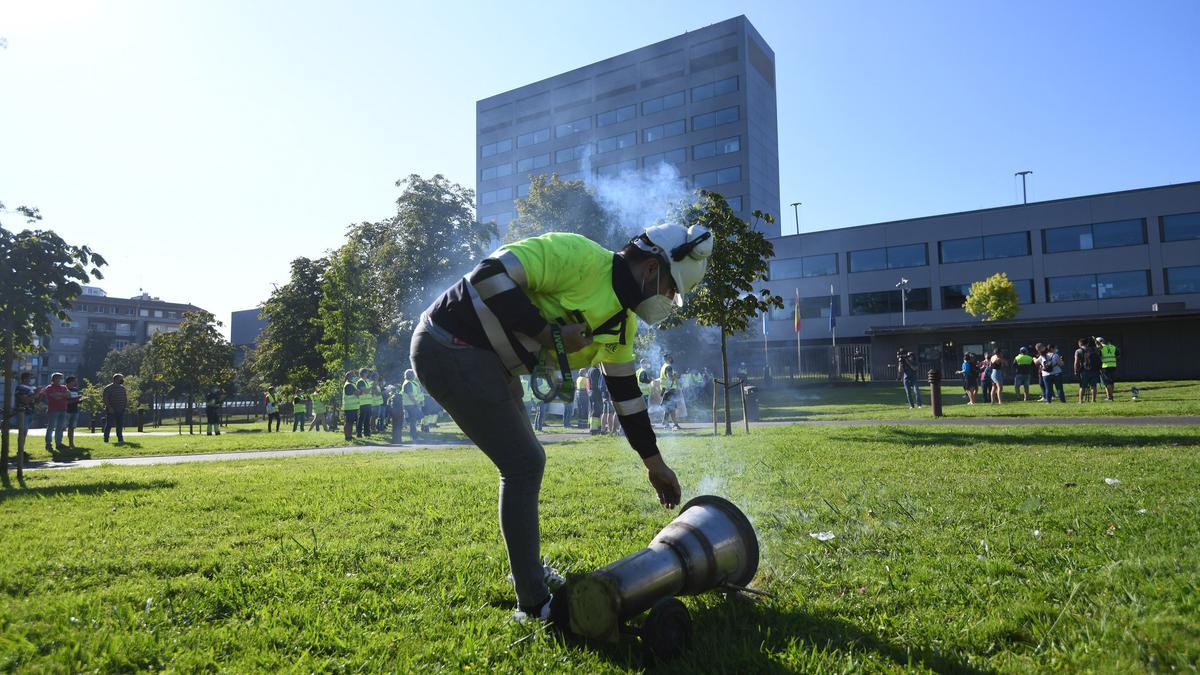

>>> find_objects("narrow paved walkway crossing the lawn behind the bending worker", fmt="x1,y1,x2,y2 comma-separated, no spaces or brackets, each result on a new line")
14,417,1200,471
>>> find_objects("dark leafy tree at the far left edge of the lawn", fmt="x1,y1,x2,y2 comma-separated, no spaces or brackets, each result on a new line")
0,204,106,486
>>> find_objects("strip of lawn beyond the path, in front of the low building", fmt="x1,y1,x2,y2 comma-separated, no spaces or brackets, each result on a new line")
753,380,1200,422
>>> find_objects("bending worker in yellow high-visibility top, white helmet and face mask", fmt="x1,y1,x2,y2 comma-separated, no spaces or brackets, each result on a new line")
412,223,713,627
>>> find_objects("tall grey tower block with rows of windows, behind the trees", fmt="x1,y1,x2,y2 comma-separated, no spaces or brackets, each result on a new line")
475,16,780,237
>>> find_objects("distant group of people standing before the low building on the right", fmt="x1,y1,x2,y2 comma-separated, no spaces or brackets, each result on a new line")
896,336,1121,407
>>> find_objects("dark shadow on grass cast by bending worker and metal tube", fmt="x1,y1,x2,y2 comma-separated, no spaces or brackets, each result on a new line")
568,601,994,674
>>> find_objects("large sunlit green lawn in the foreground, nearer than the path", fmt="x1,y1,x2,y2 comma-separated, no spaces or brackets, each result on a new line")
0,425,1200,673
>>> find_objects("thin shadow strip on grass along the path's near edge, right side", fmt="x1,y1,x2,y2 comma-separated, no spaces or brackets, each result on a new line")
827,420,1200,448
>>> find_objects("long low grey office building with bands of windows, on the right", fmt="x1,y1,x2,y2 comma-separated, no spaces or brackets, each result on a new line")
758,183,1200,380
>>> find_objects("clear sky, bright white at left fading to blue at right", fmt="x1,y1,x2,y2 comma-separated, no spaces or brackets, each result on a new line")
0,0,1200,330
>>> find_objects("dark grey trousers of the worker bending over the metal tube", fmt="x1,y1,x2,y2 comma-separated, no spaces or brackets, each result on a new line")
410,324,550,608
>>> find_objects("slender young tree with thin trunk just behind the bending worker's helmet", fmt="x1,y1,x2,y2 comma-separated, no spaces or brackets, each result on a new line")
664,190,784,436
